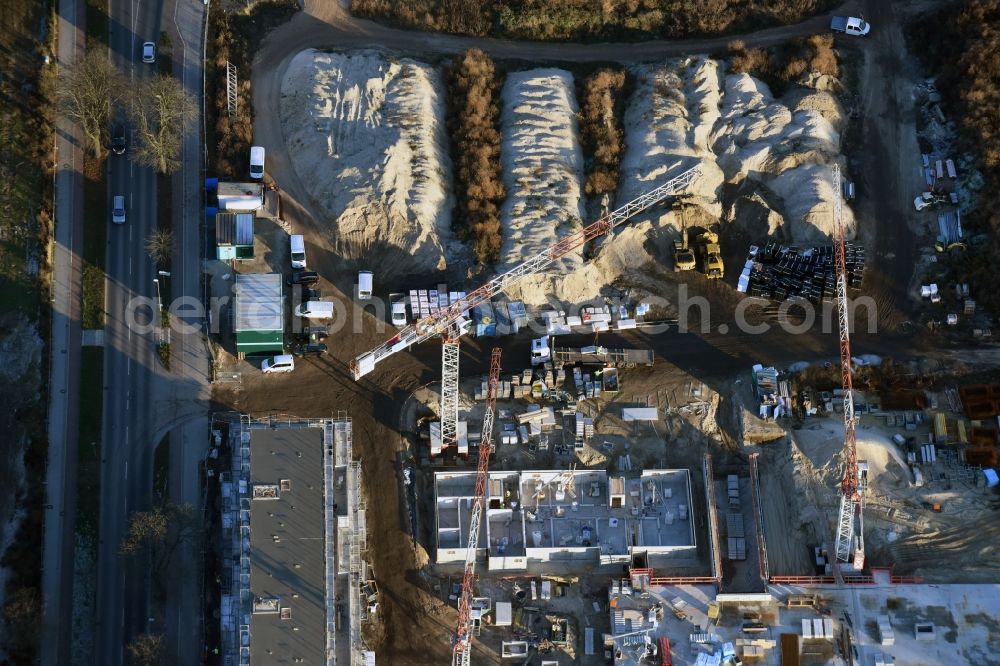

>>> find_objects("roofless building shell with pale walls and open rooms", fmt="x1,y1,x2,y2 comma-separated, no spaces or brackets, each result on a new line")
434,469,696,571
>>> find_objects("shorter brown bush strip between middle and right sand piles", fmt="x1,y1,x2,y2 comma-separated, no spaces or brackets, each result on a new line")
579,69,625,196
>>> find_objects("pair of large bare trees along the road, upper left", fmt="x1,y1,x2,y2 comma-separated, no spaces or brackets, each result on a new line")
57,49,198,174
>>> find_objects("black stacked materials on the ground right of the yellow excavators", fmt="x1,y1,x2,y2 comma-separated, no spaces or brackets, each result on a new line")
737,242,865,304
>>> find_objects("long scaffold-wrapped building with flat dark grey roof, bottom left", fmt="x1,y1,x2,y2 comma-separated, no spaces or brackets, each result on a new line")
220,416,377,666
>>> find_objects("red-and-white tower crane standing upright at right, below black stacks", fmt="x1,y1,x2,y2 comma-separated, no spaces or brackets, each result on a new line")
833,165,865,571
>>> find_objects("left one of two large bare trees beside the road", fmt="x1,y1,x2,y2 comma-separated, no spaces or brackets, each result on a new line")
56,49,126,157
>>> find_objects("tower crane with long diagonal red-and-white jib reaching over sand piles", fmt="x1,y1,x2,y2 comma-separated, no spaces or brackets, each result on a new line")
351,164,701,382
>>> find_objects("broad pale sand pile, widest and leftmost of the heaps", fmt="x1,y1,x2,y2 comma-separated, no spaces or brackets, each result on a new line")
281,49,452,272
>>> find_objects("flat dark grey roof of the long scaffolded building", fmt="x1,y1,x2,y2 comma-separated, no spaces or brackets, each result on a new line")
250,428,326,666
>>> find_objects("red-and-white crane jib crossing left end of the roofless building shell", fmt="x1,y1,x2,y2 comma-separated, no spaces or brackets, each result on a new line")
451,347,501,666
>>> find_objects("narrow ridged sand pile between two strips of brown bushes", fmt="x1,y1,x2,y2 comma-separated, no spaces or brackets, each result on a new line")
497,69,584,302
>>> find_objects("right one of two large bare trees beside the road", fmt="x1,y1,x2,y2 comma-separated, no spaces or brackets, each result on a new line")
129,74,198,174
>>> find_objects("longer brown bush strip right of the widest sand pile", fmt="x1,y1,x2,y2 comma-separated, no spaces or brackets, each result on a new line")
445,49,507,263
